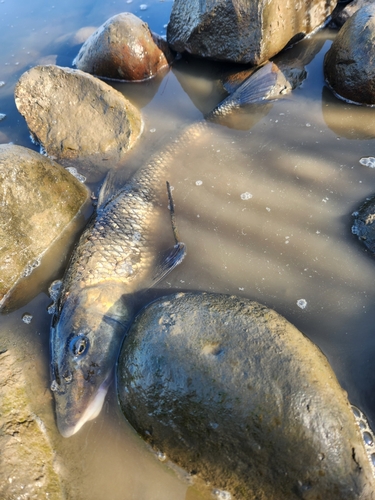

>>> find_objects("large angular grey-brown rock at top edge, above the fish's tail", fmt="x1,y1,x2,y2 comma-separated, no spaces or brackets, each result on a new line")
167,0,336,65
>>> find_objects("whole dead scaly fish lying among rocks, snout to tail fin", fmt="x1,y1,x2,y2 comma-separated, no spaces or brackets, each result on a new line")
50,63,282,437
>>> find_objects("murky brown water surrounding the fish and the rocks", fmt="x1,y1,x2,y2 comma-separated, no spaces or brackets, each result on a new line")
0,0,375,500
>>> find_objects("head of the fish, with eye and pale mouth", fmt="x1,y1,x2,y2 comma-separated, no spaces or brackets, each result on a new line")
51,288,127,437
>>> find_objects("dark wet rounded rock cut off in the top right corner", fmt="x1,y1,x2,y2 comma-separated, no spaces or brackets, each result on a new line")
324,4,375,105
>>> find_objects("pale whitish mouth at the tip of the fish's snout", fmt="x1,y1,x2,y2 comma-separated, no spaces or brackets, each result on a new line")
56,373,112,438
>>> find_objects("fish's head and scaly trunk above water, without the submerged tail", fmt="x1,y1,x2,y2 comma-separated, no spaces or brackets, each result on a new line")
51,165,185,437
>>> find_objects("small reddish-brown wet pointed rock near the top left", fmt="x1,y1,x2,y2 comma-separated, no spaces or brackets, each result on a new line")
74,12,173,81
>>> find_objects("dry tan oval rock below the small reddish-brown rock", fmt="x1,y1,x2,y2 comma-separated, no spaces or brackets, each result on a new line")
15,65,142,168
